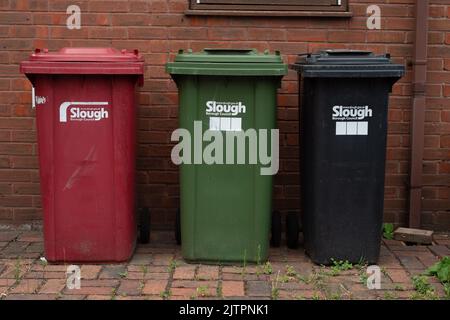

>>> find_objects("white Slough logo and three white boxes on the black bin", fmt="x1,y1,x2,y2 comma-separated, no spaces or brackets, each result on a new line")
332,106,373,136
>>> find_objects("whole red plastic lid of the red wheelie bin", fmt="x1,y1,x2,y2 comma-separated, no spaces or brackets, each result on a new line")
20,48,144,76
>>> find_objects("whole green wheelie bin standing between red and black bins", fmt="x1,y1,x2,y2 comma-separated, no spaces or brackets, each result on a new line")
167,49,287,263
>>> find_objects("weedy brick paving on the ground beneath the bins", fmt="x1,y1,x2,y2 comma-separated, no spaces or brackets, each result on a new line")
0,231,450,300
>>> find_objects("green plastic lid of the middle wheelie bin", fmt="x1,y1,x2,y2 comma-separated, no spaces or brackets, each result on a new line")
166,48,287,76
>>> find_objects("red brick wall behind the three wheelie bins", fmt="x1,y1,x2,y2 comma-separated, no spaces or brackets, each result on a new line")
0,0,450,229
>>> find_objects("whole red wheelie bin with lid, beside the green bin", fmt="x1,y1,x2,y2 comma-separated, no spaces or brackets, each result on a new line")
20,48,144,262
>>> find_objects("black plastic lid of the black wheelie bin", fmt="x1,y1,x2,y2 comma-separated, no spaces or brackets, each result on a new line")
289,50,405,78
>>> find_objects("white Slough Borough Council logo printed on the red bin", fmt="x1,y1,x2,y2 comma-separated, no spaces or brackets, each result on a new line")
59,102,109,122
